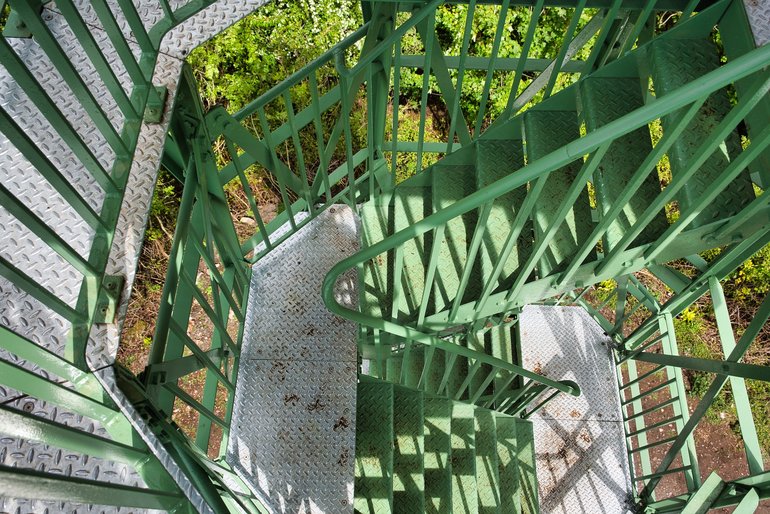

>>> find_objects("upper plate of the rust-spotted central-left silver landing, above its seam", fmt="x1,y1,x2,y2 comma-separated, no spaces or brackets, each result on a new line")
241,206,358,362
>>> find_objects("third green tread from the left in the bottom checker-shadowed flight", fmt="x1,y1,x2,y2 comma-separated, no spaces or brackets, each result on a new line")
423,396,452,514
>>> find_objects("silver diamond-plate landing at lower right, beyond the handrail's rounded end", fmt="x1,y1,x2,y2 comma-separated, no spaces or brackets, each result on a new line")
519,306,631,514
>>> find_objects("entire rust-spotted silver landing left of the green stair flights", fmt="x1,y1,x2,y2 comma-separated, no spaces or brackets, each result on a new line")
227,206,358,513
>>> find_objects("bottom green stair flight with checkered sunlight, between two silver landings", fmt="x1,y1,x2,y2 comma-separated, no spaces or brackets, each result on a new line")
355,379,538,513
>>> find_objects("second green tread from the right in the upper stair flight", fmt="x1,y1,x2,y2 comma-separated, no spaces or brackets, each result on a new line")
580,77,668,249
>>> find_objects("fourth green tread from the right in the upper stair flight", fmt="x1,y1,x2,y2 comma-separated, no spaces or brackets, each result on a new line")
476,139,534,290
